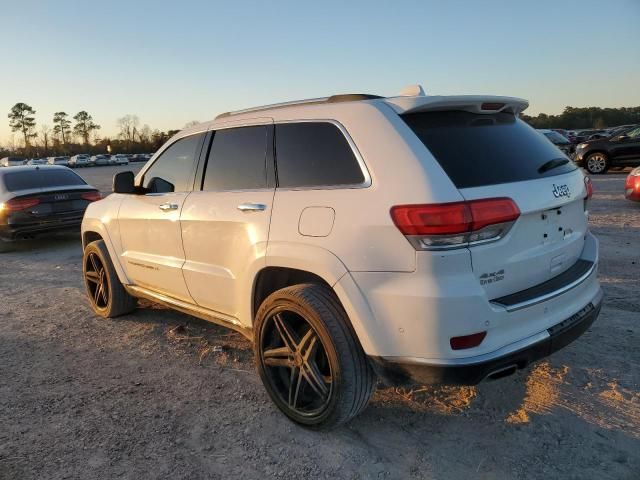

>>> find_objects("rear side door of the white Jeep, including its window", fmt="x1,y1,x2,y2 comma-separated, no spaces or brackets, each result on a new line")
180,121,275,317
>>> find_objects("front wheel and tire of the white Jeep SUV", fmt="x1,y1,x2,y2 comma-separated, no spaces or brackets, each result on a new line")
82,240,137,318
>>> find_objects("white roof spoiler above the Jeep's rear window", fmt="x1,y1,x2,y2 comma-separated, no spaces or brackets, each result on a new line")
385,95,529,115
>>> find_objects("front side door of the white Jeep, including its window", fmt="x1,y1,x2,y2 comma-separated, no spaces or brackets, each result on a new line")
118,133,205,301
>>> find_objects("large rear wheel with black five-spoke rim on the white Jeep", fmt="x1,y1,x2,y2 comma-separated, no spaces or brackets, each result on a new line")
254,284,375,429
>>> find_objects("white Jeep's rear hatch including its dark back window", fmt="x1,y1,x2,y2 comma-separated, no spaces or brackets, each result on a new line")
402,111,587,299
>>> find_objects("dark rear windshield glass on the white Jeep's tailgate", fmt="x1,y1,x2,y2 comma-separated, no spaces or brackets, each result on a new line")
401,111,577,188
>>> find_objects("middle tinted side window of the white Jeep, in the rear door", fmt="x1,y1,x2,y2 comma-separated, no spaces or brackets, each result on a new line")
203,126,267,191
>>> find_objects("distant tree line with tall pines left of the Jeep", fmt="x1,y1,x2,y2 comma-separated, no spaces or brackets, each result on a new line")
0,102,182,157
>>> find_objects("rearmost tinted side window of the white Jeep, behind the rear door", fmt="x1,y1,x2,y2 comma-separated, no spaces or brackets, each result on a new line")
276,122,364,188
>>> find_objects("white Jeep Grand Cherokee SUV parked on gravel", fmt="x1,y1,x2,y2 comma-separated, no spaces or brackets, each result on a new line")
82,88,602,427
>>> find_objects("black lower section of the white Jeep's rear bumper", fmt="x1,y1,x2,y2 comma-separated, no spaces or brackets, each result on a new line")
369,290,602,385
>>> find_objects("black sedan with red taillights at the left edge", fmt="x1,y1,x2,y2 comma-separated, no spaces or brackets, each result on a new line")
0,165,102,252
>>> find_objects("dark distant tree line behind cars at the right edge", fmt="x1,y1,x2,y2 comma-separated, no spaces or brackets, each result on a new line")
520,107,640,130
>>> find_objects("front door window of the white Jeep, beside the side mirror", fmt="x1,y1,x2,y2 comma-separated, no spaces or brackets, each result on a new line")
142,134,204,193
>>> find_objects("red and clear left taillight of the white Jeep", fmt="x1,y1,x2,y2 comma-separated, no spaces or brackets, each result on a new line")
391,198,520,250
